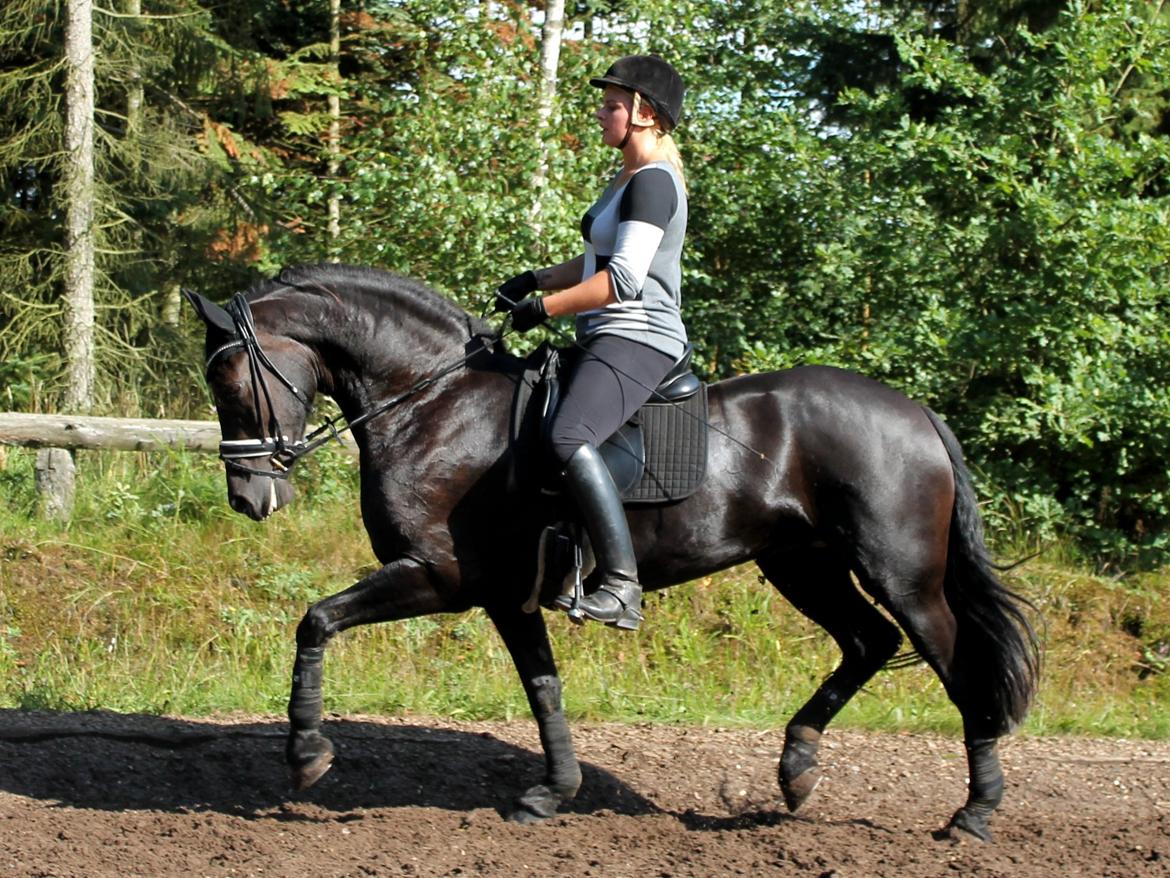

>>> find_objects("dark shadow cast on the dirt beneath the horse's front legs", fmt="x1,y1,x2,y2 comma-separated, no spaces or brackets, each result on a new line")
0,709,661,819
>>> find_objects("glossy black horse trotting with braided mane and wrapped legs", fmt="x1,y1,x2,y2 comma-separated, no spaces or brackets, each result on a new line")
188,266,1039,839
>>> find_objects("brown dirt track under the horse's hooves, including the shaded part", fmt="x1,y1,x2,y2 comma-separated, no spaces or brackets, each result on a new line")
0,711,1170,878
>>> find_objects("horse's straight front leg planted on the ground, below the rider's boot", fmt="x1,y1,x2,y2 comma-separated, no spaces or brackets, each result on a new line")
487,604,581,823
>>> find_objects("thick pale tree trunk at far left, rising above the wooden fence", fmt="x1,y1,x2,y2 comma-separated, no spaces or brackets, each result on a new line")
62,0,95,412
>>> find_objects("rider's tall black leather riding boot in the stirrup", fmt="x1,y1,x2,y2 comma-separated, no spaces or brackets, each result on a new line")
556,445,642,631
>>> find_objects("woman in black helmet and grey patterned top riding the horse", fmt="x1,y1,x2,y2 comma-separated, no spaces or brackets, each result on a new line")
496,55,687,630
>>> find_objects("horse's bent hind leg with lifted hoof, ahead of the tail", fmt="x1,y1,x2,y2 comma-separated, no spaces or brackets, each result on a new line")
757,550,902,811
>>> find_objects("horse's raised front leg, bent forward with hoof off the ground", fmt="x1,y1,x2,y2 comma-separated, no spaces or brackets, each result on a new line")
285,558,446,789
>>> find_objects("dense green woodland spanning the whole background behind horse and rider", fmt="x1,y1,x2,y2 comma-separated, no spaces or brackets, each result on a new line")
0,0,1170,564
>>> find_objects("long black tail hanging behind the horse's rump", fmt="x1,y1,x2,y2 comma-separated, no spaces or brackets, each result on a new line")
925,409,1040,736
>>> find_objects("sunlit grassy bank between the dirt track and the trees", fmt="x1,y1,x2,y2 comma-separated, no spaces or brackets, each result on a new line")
0,451,1170,738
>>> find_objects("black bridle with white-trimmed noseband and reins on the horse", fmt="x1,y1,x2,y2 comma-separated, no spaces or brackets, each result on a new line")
204,293,497,479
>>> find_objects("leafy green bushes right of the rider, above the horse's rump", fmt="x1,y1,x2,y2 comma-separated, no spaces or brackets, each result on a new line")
688,5,1170,560
